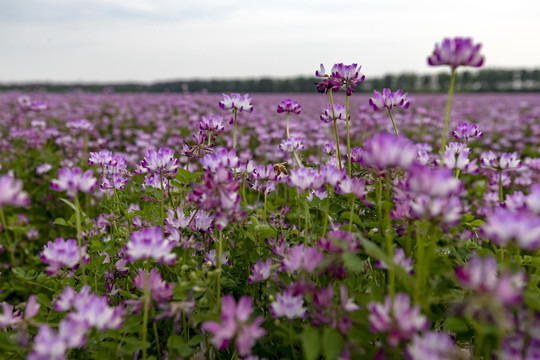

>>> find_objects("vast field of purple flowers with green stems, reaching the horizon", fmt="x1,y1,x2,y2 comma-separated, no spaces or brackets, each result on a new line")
0,38,540,360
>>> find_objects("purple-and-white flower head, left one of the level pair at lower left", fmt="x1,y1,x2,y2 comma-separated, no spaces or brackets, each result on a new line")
40,238,90,275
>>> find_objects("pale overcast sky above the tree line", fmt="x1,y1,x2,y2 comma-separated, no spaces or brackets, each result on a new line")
0,0,540,83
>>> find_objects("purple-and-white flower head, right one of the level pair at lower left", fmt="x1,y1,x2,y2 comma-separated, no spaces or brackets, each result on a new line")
126,226,176,265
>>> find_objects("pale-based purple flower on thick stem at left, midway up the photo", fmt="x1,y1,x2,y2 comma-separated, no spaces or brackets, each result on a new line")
51,167,97,199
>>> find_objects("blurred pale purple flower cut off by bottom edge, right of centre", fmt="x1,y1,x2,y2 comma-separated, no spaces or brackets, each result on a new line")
407,331,459,360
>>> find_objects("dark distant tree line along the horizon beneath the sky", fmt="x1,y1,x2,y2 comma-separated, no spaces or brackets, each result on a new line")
0,69,540,93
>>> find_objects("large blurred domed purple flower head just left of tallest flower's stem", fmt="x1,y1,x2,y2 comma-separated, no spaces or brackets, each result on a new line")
359,133,417,170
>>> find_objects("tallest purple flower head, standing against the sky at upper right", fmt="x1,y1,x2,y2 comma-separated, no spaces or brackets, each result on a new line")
428,37,484,71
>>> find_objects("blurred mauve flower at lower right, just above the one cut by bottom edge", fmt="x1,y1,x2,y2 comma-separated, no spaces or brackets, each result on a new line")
367,293,429,347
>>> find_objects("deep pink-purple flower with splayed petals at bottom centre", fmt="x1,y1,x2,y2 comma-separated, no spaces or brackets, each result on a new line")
202,295,266,356
